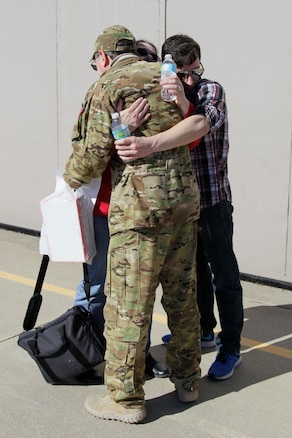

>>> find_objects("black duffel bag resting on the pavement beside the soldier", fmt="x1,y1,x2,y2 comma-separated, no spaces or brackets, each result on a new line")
18,306,105,383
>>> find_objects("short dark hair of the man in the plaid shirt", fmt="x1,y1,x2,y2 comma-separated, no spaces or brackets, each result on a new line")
161,34,201,68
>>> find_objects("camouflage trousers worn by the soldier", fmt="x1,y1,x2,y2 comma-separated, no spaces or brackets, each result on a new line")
104,219,201,406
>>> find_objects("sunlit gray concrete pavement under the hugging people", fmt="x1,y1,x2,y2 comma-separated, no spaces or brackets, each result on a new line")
0,229,292,438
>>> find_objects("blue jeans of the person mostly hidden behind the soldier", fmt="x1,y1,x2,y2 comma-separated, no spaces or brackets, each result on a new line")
73,216,152,354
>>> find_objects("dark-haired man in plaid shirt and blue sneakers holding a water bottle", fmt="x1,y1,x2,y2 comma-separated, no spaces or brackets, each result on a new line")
116,34,243,380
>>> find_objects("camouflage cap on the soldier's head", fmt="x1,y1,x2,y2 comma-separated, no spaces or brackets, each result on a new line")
92,25,136,59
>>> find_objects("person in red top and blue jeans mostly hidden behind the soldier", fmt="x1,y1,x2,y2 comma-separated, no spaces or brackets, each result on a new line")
67,40,169,385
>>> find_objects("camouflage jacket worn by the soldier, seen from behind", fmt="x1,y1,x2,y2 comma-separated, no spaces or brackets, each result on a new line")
64,54,199,231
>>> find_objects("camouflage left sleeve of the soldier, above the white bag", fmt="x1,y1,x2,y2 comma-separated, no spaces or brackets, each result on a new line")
63,86,113,188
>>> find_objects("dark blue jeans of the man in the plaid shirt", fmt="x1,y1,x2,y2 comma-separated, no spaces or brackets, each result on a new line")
197,200,243,354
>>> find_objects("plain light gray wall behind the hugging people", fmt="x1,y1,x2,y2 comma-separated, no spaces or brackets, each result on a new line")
0,0,292,282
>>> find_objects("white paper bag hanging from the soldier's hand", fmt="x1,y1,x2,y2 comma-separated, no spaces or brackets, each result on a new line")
39,176,97,264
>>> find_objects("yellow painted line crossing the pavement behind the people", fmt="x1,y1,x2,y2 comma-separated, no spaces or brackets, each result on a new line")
0,271,292,359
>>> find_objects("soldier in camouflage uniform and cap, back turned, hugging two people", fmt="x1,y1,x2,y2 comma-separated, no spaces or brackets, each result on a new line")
64,26,201,423
